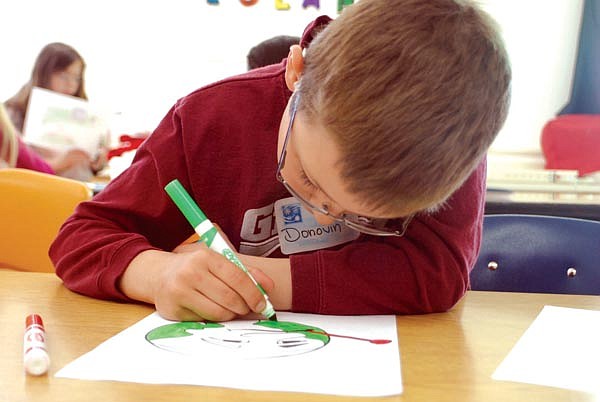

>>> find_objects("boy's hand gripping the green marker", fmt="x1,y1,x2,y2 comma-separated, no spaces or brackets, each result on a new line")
141,243,273,321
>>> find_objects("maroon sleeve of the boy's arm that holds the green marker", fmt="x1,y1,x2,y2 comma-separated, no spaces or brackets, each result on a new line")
49,102,195,300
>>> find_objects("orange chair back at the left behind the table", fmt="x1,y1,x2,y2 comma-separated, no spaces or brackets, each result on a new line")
0,168,92,272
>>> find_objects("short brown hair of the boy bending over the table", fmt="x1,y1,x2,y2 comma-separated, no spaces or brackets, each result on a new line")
299,0,511,217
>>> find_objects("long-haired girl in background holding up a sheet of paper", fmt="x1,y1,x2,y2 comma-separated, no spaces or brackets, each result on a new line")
5,42,106,180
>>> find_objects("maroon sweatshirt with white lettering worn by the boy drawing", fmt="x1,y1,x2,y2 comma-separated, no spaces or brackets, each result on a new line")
50,18,485,315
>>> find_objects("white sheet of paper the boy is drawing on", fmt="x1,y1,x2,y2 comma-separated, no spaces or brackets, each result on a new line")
56,312,402,396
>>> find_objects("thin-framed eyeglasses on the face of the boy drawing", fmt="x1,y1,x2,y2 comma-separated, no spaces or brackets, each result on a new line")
276,92,414,236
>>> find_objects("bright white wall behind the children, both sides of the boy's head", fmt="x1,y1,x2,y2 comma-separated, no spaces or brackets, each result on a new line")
0,0,583,159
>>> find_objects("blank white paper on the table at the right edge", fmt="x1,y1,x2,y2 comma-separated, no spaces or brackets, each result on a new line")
492,306,600,395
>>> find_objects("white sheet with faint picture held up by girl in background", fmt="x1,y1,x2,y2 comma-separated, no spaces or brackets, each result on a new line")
23,87,110,159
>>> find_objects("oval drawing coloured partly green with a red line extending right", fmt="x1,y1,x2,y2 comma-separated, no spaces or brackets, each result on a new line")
146,320,391,359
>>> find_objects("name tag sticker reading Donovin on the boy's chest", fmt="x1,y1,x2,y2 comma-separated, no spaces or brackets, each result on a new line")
274,197,360,255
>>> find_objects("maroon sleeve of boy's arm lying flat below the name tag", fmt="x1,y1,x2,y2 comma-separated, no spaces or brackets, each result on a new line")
290,160,486,315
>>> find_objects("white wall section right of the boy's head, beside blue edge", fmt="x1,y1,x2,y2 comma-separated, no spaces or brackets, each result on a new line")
480,0,583,163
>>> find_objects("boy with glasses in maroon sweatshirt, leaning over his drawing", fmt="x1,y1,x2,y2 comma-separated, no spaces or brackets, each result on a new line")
50,0,511,321
